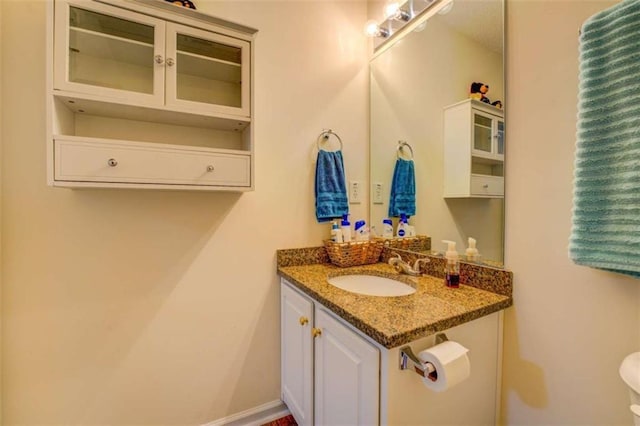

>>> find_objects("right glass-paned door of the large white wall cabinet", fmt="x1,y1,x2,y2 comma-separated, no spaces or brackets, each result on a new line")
166,23,250,117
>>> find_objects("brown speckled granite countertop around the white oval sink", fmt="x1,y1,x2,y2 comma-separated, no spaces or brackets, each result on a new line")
278,263,513,349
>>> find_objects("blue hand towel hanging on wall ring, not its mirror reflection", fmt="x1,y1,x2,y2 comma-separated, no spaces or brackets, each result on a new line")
315,150,349,222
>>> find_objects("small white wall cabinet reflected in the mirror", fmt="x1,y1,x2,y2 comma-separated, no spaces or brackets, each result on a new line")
443,99,505,198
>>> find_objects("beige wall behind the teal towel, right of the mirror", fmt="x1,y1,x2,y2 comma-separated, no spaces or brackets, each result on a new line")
503,0,640,425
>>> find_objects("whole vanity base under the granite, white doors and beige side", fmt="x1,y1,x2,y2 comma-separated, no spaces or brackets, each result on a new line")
280,278,502,426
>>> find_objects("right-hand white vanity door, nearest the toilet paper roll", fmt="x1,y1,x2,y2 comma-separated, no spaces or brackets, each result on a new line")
315,308,380,425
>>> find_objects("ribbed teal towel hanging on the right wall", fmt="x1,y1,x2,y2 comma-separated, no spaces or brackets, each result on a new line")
569,0,640,278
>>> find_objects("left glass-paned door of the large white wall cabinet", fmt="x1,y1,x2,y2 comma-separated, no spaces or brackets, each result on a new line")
55,2,165,103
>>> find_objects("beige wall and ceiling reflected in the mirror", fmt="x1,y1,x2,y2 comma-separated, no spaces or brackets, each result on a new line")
369,0,508,266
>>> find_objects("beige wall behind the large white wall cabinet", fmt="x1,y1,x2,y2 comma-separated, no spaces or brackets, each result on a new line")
1,0,368,425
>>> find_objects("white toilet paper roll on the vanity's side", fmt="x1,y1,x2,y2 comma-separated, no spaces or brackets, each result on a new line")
418,341,471,392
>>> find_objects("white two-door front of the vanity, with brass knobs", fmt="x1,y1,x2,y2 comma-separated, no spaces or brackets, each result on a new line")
281,280,380,425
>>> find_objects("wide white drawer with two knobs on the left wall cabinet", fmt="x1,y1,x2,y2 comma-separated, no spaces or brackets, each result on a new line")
54,139,251,187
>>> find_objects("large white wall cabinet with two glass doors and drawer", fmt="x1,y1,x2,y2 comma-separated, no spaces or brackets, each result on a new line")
47,0,257,191
